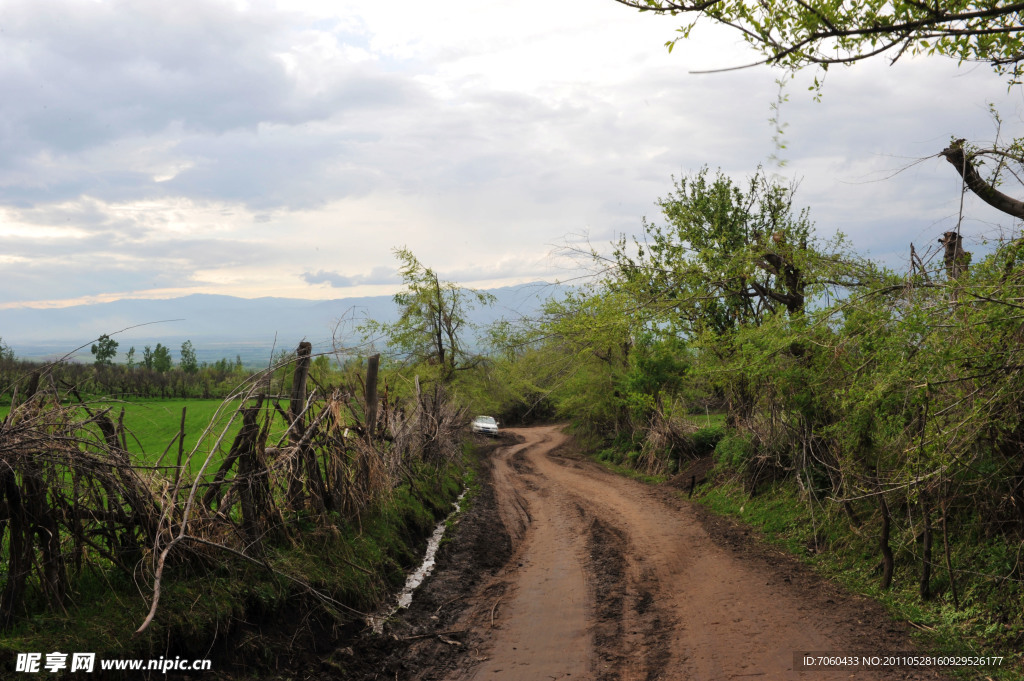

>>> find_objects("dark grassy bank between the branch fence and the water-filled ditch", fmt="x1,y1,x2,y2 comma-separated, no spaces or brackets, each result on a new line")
0,458,464,679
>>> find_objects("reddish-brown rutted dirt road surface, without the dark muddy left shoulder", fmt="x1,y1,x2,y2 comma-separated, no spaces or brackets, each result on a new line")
436,427,940,681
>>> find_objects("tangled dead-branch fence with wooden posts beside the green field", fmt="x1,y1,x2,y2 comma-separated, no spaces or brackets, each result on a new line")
0,343,465,631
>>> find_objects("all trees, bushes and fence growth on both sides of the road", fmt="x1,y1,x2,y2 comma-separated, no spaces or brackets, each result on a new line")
6,173,1024,676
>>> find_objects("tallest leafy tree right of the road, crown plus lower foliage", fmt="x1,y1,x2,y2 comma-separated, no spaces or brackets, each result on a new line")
609,168,877,425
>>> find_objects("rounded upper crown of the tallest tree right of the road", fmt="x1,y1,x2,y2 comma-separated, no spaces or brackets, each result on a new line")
614,168,857,338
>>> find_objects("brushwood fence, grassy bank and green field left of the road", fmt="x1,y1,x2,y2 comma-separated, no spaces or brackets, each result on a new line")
0,323,466,671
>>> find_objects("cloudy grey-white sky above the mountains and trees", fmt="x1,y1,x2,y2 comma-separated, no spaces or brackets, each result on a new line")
0,0,1024,309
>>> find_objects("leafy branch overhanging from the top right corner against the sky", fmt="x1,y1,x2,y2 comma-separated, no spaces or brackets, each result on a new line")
616,0,1024,83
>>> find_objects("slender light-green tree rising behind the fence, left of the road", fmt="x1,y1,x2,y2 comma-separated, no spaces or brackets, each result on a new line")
359,248,495,382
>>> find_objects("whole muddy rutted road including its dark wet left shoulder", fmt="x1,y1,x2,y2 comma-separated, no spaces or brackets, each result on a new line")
328,427,945,681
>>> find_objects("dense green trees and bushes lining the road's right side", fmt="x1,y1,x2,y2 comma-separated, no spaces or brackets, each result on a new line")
468,169,1024,673
